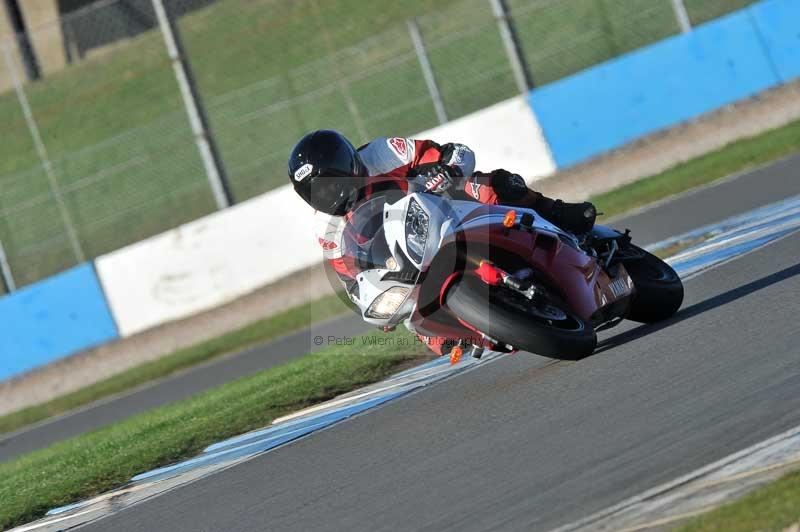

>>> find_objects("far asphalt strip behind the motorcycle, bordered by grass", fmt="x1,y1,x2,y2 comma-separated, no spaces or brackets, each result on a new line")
0,152,800,461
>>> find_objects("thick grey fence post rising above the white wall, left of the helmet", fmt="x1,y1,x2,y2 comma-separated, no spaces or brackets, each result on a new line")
152,0,234,209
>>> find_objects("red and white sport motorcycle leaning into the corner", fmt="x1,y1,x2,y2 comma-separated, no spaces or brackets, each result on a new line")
343,189,683,360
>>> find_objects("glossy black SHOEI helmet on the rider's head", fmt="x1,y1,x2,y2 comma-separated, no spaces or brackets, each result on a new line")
289,130,367,216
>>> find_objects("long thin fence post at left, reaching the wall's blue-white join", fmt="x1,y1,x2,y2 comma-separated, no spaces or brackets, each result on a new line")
3,46,86,263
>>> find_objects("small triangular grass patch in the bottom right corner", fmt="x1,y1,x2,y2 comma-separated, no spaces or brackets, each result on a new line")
679,472,800,532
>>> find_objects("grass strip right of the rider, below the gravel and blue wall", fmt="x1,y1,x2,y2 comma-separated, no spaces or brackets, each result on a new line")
591,121,800,217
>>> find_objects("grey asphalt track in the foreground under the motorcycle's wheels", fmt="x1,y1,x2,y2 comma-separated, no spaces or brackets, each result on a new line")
79,210,800,531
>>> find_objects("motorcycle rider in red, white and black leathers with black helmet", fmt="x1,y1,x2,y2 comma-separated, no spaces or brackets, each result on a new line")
289,130,597,354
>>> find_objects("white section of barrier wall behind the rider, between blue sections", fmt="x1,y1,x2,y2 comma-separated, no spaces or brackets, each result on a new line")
97,97,555,337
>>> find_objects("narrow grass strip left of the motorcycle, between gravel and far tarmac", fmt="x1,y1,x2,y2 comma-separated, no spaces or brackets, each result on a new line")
0,295,346,434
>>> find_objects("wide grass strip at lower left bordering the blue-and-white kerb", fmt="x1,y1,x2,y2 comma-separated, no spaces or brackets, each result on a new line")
0,332,432,528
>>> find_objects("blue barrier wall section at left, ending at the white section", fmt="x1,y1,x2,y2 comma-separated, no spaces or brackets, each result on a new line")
0,263,118,380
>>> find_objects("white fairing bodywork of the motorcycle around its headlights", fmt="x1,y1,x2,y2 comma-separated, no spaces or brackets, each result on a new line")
351,193,577,327
